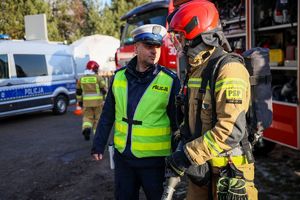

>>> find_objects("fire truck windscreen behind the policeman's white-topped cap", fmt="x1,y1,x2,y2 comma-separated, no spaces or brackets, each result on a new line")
121,9,168,45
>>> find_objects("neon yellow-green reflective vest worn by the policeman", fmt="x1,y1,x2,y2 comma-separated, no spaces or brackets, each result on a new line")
112,69,173,158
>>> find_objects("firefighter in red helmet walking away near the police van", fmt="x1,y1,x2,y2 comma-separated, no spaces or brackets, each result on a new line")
76,61,107,140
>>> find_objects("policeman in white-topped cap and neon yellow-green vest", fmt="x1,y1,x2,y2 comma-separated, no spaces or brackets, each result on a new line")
92,24,180,200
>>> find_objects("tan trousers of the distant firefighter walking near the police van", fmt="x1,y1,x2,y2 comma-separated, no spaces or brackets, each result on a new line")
82,106,102,132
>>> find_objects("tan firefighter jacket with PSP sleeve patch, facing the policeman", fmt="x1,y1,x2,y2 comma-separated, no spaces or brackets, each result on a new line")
184,48,250,167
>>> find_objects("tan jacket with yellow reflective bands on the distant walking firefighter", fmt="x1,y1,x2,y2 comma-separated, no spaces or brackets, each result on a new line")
76,74,106,107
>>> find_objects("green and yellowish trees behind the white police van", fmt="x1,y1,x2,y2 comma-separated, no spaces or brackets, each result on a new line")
0,0,148,42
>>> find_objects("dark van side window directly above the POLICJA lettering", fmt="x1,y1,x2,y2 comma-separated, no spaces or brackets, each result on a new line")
14,54,48,77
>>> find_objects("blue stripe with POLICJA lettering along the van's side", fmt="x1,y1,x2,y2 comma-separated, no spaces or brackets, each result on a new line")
0,83,76,102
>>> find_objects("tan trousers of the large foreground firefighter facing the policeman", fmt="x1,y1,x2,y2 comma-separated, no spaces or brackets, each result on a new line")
187,164,258,200
